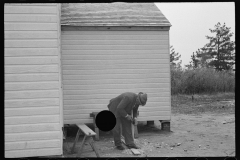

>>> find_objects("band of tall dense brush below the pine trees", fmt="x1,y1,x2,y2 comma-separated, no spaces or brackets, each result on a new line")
171,68,235,95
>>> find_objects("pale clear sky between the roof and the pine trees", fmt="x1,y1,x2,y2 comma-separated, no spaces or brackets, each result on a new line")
155,2,235,66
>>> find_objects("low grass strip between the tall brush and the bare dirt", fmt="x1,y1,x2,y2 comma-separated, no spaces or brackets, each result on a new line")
171,92,235,114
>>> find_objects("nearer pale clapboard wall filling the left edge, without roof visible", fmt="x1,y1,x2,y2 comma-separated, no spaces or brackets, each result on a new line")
4,4,63,158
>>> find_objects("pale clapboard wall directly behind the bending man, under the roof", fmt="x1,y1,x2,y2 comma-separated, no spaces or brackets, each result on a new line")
61,30,171,124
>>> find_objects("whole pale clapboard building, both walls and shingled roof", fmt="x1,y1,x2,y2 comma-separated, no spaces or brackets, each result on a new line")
4,3,171,157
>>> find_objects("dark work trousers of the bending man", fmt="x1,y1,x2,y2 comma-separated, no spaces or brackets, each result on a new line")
112,117,134,146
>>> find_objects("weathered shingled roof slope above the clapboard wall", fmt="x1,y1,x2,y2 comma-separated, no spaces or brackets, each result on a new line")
61,2,171,26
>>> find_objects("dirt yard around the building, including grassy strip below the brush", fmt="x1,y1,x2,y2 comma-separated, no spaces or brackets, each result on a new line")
63,95,235,157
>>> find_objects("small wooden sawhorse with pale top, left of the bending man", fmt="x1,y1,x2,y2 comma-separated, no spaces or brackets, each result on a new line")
72,124,99,157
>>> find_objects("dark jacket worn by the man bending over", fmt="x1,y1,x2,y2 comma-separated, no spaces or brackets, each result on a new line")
108,92,139,118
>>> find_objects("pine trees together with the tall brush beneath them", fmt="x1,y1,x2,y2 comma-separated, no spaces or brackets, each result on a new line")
170,23,235,94
